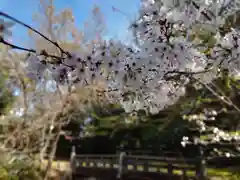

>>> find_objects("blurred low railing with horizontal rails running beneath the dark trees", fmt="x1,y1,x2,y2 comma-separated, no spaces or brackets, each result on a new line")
70,147,205,180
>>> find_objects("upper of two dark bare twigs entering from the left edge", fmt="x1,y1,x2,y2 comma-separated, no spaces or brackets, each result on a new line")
0,11,66,54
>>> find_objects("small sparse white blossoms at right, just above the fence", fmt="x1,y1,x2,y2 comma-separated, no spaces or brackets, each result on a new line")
181,109,240,157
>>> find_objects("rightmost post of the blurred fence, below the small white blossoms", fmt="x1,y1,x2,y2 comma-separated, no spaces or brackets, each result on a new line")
196,145,207,180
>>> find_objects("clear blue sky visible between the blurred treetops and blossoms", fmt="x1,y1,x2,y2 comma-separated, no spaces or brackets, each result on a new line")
0,0,140,45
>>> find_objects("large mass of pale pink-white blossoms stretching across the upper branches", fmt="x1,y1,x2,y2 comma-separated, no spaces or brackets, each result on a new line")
1,0,239,113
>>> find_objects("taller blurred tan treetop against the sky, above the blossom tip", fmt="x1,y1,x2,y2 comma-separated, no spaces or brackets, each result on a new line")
29,0,82,54
